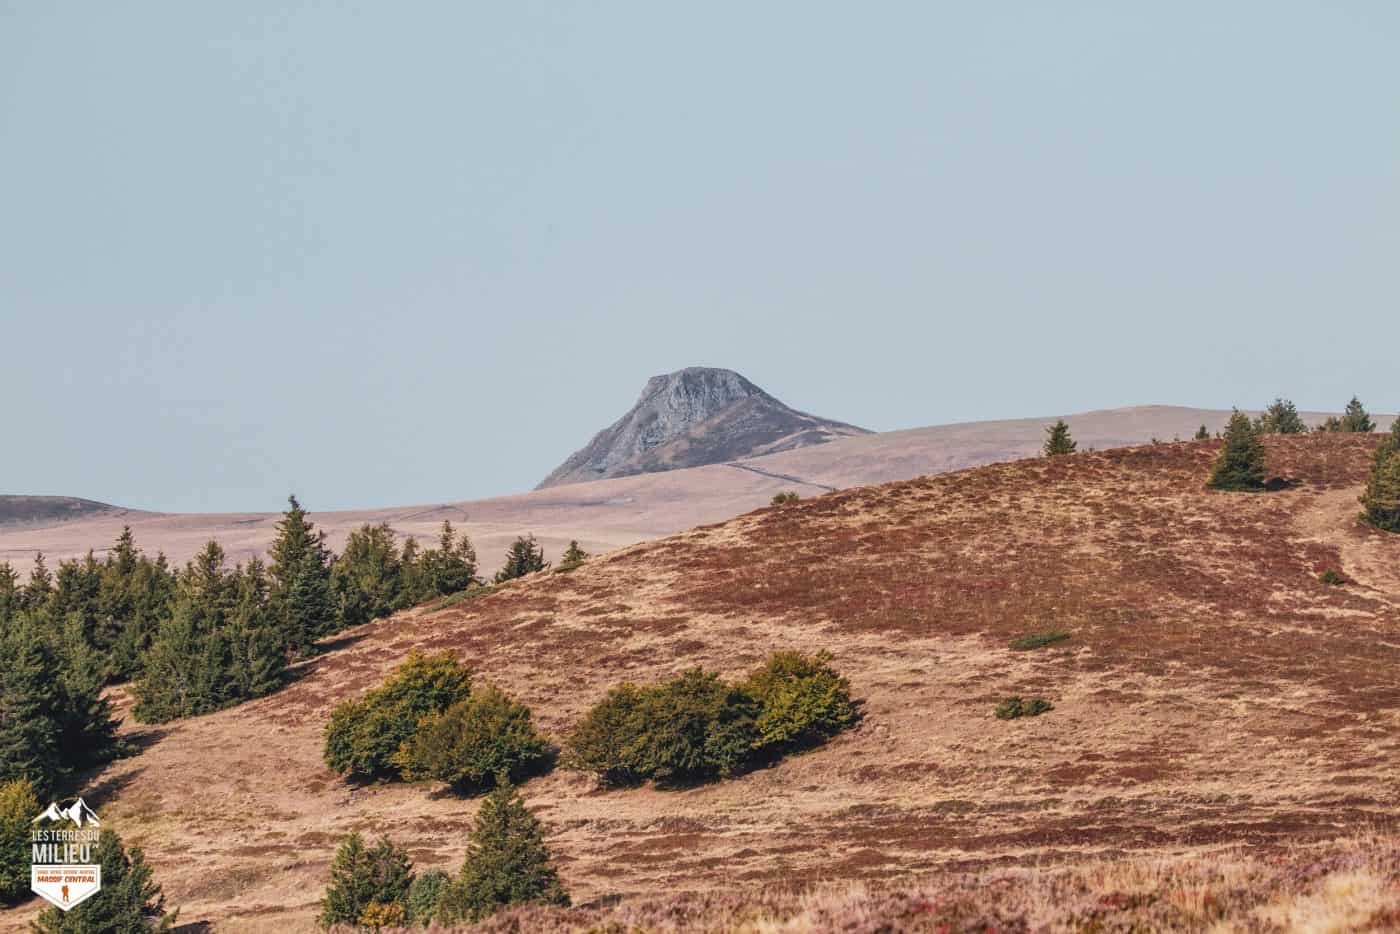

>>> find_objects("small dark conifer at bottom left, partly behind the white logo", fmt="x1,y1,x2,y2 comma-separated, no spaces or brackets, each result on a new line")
34,829,179,934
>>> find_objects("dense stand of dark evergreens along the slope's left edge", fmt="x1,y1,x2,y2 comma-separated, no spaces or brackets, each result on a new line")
0,497,568,794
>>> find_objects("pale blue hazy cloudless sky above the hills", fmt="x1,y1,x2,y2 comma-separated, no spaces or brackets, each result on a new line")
0,0,1400,510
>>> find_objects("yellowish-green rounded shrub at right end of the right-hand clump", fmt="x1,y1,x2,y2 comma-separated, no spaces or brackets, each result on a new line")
739,651,860,751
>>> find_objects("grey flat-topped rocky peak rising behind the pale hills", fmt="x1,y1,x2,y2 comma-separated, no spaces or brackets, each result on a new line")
535,367,869,489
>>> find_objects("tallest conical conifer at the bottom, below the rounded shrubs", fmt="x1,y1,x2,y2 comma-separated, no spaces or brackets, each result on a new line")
437,780,568,924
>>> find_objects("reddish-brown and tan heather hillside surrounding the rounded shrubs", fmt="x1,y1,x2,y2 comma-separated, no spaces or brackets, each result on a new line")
4,435,1400,931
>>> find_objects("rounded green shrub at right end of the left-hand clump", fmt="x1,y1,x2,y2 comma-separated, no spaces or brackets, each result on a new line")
395,685,550,790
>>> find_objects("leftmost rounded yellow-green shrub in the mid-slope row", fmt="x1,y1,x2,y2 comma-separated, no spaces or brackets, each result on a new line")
325,651,472,780
